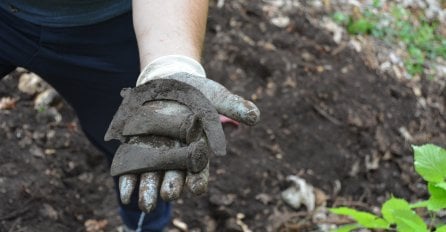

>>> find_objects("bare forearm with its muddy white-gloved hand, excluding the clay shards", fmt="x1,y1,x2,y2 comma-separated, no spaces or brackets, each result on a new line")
110,0,259,211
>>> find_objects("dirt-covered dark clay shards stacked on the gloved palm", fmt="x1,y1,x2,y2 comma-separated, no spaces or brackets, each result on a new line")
105,79,226,176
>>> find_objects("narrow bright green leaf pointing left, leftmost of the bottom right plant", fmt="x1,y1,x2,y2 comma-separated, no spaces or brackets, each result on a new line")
330,207,390,229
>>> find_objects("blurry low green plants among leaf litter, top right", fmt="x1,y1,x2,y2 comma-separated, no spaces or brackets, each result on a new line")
332,0,446,75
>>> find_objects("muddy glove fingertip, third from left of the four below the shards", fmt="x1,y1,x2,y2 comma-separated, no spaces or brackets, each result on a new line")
160,170,186,201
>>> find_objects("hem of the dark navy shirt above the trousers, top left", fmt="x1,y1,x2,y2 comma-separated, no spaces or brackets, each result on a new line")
0,0,131,27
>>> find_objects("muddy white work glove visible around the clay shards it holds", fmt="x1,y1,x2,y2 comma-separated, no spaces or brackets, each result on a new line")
119,55,260,212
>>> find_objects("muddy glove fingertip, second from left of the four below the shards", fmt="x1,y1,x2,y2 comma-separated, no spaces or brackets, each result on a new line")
138,172,161,212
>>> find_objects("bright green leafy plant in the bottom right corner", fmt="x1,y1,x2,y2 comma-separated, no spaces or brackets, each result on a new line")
330,144,446,232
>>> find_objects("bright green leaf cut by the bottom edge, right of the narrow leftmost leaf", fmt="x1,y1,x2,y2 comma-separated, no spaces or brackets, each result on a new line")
394,210,428,232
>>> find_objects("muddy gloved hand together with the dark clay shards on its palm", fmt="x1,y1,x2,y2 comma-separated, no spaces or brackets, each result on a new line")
105,55,260,212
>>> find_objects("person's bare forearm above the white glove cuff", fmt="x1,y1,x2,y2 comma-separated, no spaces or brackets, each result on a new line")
133,0,208,68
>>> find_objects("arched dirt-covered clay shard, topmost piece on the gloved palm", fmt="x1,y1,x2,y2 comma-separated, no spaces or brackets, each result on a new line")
105,77,226,155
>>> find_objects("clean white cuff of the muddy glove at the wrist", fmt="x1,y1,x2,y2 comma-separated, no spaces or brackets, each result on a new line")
136,55,206,86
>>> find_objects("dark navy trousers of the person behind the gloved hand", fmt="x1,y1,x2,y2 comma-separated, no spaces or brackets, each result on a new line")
0,9,171,231
